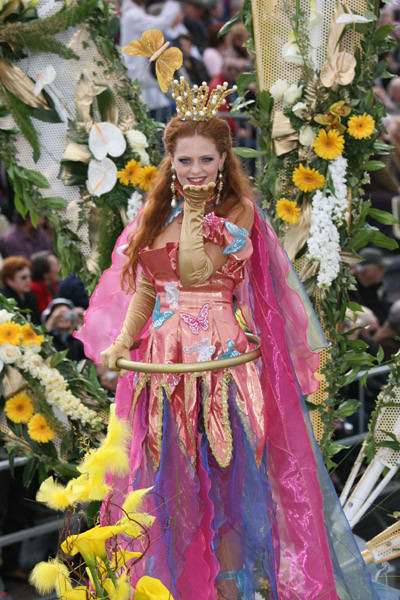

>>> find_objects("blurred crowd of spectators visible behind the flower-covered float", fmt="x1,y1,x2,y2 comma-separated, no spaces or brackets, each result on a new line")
0,0,400,592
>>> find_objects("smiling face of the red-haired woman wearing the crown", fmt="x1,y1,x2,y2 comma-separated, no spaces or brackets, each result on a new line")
171,135,226,187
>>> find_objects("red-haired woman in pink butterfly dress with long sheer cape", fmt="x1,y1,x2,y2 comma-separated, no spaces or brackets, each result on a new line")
78,117,377,600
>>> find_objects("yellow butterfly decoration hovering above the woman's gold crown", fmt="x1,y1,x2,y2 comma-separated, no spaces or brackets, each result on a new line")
122,29,183,92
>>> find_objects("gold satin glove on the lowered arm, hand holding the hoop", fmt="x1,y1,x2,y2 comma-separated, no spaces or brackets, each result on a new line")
100,273,156,377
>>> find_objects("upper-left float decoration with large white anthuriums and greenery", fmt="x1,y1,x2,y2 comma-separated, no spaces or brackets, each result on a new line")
0,0,159,287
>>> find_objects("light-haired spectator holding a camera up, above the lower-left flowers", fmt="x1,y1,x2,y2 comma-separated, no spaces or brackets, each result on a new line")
41,298,85,361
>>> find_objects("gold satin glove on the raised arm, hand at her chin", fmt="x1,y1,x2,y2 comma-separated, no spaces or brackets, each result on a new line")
179,183,215,287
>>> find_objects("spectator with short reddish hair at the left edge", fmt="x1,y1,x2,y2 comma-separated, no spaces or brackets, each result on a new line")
1,256,40,325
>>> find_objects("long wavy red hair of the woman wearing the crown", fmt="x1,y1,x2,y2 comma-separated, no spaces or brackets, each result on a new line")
122,117,251,290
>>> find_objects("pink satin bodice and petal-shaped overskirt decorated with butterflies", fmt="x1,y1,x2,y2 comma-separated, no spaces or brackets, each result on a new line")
134,213,265,468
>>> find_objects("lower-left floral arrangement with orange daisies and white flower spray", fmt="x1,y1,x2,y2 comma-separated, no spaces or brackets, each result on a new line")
0,296,109,485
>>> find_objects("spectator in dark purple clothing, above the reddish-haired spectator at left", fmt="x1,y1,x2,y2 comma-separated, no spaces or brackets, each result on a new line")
0,211,53,260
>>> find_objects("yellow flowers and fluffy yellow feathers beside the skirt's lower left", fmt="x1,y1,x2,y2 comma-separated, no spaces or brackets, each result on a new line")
30,406,173,600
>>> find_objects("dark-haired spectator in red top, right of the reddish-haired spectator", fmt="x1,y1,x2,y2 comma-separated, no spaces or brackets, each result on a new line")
31,250,60,313
